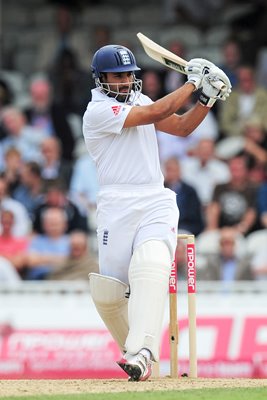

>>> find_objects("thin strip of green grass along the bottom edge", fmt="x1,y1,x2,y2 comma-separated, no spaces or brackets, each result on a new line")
3,387,267,400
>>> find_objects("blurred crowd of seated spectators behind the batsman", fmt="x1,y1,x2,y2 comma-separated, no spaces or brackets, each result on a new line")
0,2,267,282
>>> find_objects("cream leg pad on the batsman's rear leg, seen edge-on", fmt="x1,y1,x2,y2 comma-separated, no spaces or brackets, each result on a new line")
89,273,129,352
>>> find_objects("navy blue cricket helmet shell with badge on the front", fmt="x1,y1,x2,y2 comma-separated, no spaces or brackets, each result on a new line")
91,44,140,79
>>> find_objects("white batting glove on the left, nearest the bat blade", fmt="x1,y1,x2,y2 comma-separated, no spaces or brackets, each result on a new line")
185,58,218,90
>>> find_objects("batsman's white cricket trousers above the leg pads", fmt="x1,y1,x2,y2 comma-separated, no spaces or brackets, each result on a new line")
96,185,179,284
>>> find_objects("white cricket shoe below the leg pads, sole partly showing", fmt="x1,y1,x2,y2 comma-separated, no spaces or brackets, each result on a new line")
117,350,152,381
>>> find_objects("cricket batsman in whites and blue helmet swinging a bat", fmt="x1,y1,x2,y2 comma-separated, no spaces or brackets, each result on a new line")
83,45,231,381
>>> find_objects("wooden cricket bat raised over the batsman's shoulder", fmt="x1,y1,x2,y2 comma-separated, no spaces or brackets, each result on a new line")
136,32,225,90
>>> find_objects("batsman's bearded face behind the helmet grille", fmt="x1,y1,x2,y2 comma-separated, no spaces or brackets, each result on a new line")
105,72,134,102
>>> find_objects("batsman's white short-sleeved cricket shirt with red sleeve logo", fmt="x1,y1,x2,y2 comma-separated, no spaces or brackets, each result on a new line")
83,88,163,187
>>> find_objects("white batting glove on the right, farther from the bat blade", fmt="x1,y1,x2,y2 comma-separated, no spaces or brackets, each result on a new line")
199,66,232,107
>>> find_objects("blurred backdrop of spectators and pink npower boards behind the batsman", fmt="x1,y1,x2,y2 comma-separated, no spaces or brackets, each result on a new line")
0,0,267,379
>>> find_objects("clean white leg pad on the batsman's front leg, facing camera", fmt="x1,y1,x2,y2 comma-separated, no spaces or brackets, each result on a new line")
126,240,171,361
